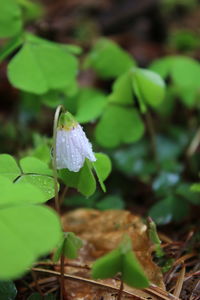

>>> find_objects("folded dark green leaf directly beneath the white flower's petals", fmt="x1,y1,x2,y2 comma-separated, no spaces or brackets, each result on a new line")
59,160,96,197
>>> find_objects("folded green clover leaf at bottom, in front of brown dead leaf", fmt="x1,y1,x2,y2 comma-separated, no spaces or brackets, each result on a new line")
92,236,149,288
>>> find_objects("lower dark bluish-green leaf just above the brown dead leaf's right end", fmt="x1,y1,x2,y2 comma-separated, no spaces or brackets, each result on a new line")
149,196,189,225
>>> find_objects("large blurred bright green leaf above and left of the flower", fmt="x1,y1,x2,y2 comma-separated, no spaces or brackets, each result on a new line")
8,39,77,94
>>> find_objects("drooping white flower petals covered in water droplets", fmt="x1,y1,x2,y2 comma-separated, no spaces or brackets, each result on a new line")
56,123,96,172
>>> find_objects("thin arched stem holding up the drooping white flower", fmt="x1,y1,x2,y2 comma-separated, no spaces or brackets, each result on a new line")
52,105,64,214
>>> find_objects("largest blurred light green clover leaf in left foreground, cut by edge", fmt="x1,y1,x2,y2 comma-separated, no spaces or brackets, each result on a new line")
0,177,61,280
